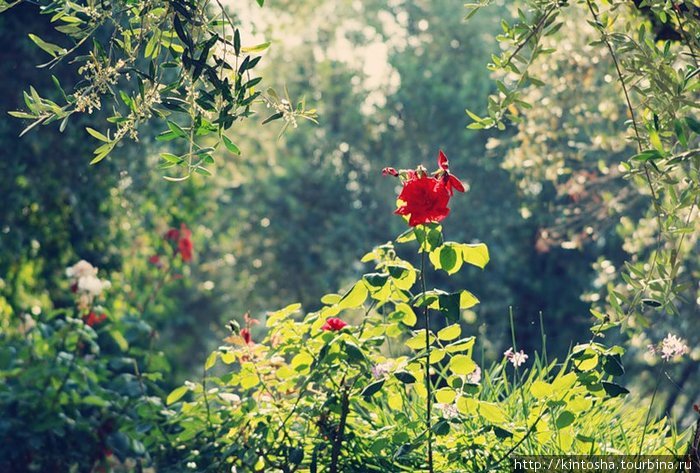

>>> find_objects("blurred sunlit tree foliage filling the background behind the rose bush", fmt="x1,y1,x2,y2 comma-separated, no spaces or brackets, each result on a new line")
0,0,700,470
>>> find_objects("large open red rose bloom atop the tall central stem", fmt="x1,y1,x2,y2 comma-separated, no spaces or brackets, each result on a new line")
395,176,450,227
